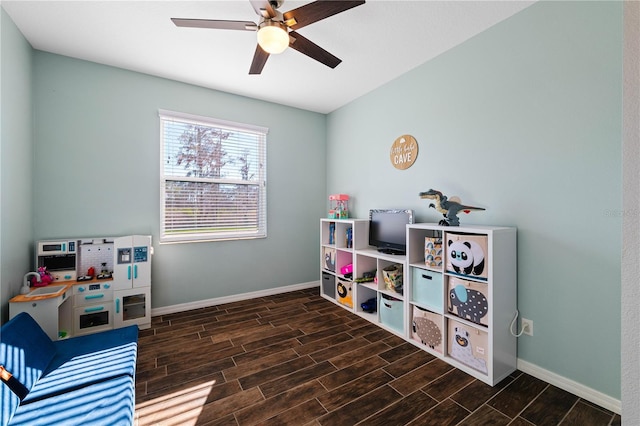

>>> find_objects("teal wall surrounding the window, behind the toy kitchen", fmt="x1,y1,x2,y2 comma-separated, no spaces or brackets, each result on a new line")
32,51,326,308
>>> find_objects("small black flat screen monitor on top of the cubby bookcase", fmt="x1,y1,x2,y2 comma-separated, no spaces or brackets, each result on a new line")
369,209,413,254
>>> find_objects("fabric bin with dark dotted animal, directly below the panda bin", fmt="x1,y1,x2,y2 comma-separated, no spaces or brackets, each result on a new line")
447,277,489,327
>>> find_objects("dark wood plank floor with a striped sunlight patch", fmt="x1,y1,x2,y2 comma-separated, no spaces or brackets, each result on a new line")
136,289,621,426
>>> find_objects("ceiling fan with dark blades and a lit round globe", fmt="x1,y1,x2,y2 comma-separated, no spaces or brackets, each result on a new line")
171,0,364,74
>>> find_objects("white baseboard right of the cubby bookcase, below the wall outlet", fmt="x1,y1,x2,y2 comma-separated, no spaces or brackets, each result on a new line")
517,358,622,414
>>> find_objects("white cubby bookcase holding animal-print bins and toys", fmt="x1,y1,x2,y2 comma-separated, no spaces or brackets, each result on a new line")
320,219,517,386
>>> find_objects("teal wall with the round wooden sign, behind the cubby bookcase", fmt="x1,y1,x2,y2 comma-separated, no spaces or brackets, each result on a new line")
327,2,622,399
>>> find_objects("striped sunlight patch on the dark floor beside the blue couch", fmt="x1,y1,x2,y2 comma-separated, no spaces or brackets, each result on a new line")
135,380,216,426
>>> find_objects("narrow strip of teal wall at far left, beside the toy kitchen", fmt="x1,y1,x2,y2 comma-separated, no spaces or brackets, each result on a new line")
0,8,33,321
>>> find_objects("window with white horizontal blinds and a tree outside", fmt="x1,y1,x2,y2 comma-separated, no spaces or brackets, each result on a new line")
159,110,268,242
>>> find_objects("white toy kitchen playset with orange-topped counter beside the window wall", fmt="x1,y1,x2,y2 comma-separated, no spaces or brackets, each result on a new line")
9,235,153,340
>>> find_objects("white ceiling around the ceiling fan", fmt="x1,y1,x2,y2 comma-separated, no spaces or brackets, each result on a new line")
2,0,535,113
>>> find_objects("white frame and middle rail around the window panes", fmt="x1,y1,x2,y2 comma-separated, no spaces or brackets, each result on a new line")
158,109,269,244
